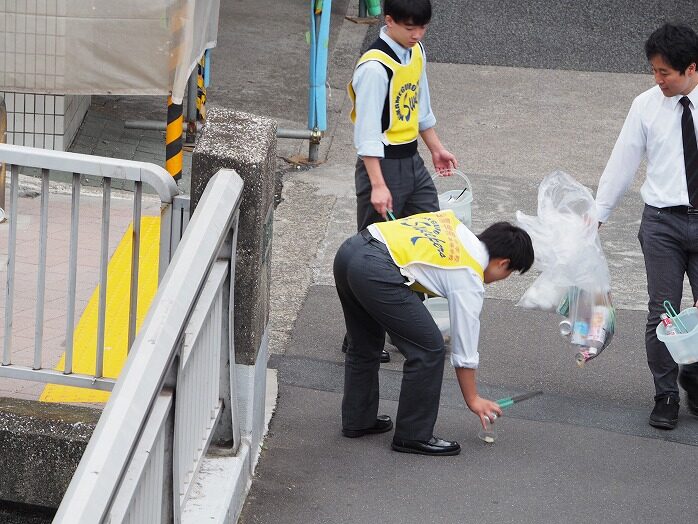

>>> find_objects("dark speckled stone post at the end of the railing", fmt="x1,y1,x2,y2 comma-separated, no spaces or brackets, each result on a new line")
191,106,276,365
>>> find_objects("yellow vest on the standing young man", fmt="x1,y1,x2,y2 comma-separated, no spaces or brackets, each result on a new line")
347,43,424,145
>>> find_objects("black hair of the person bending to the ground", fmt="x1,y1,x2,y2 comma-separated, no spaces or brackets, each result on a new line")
477,222,533,274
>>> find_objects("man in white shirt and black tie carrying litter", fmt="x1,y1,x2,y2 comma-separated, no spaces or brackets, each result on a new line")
596,24,698,429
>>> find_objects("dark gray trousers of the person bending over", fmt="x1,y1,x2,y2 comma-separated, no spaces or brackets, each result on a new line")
334,231,445,440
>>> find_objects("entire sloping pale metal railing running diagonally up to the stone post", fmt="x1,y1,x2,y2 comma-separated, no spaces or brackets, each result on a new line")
54,170,243,524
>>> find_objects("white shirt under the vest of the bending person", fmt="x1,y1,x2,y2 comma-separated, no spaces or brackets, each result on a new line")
368,224,490,369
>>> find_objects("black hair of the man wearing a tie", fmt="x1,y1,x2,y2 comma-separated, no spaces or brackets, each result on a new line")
645,24,698,75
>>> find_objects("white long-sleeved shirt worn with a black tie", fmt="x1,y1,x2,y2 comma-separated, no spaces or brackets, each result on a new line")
596,86,698,222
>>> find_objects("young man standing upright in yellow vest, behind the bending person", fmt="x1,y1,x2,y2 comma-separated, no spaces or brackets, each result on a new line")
343,0,457,362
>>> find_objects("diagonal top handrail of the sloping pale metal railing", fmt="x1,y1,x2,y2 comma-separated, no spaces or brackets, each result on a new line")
53,170,243,524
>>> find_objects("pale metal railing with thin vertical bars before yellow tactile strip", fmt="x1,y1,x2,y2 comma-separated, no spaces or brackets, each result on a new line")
0,144,179,390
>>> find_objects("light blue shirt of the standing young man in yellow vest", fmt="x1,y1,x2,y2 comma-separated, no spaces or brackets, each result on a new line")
351,26,436,158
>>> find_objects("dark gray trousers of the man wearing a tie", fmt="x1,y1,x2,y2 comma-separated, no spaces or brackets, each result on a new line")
638,205,698,400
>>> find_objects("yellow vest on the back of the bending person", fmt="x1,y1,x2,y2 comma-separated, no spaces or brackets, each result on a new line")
374,209,485,294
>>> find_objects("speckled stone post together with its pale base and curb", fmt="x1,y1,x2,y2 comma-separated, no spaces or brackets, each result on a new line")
182,106,277,524
